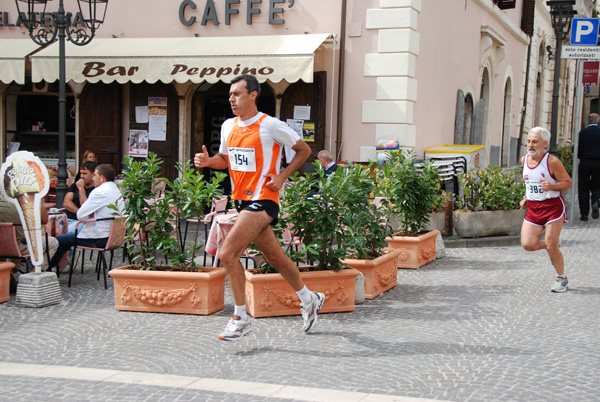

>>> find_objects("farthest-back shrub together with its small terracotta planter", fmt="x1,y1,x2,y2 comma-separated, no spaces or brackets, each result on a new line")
377,151,441,269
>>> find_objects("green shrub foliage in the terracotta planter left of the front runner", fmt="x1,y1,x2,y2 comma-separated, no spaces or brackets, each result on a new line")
111,152,225,271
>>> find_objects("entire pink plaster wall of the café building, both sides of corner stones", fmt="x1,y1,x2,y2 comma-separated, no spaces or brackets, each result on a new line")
0,0,527,160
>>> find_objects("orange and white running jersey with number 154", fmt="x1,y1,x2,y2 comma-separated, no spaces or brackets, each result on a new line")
219,112,300,204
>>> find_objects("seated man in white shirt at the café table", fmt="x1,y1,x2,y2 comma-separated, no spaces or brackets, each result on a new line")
50,164,122,267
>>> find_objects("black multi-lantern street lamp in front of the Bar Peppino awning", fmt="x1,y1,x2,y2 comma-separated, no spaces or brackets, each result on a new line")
15,0,108,208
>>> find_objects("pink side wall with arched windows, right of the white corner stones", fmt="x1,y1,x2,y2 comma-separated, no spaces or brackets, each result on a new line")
415,1,527,162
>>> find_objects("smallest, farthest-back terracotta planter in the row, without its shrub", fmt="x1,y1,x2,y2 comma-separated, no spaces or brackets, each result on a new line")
386,230,440,269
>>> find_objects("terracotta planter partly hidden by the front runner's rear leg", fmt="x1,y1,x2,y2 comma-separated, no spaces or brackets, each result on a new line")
245,268,360,317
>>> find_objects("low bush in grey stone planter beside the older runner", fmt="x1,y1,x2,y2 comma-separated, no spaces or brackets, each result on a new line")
453,165,525,237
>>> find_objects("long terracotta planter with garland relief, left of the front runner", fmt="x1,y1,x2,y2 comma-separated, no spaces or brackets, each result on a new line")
108,265,226,315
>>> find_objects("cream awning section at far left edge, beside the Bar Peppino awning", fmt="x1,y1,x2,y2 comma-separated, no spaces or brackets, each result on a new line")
0,39,40,85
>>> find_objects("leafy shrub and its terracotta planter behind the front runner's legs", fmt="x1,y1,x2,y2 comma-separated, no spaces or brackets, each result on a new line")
246,163,359,317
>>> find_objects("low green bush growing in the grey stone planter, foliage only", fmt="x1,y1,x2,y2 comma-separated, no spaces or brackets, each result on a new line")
456,165,525,211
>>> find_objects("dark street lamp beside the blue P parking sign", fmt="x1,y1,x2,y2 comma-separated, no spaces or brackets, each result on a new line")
546,0,575,154
